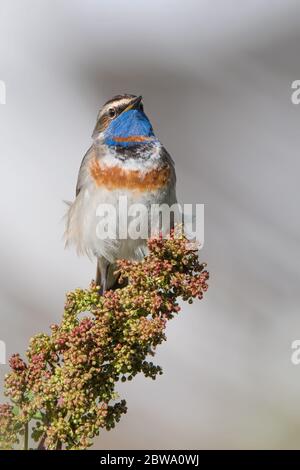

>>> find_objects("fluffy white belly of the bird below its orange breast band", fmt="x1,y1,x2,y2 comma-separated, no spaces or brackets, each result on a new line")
66,184,176,263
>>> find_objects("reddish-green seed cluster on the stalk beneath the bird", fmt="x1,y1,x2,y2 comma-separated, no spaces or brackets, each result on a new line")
0,232,208,450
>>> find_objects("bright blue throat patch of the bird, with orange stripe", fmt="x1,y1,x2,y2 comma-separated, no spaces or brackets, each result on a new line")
104,109,157,147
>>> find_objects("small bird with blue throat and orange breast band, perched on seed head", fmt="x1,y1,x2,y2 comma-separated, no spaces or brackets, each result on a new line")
65,94,176,293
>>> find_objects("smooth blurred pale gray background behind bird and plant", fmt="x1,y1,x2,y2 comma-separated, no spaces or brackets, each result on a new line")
0,0,300,449
